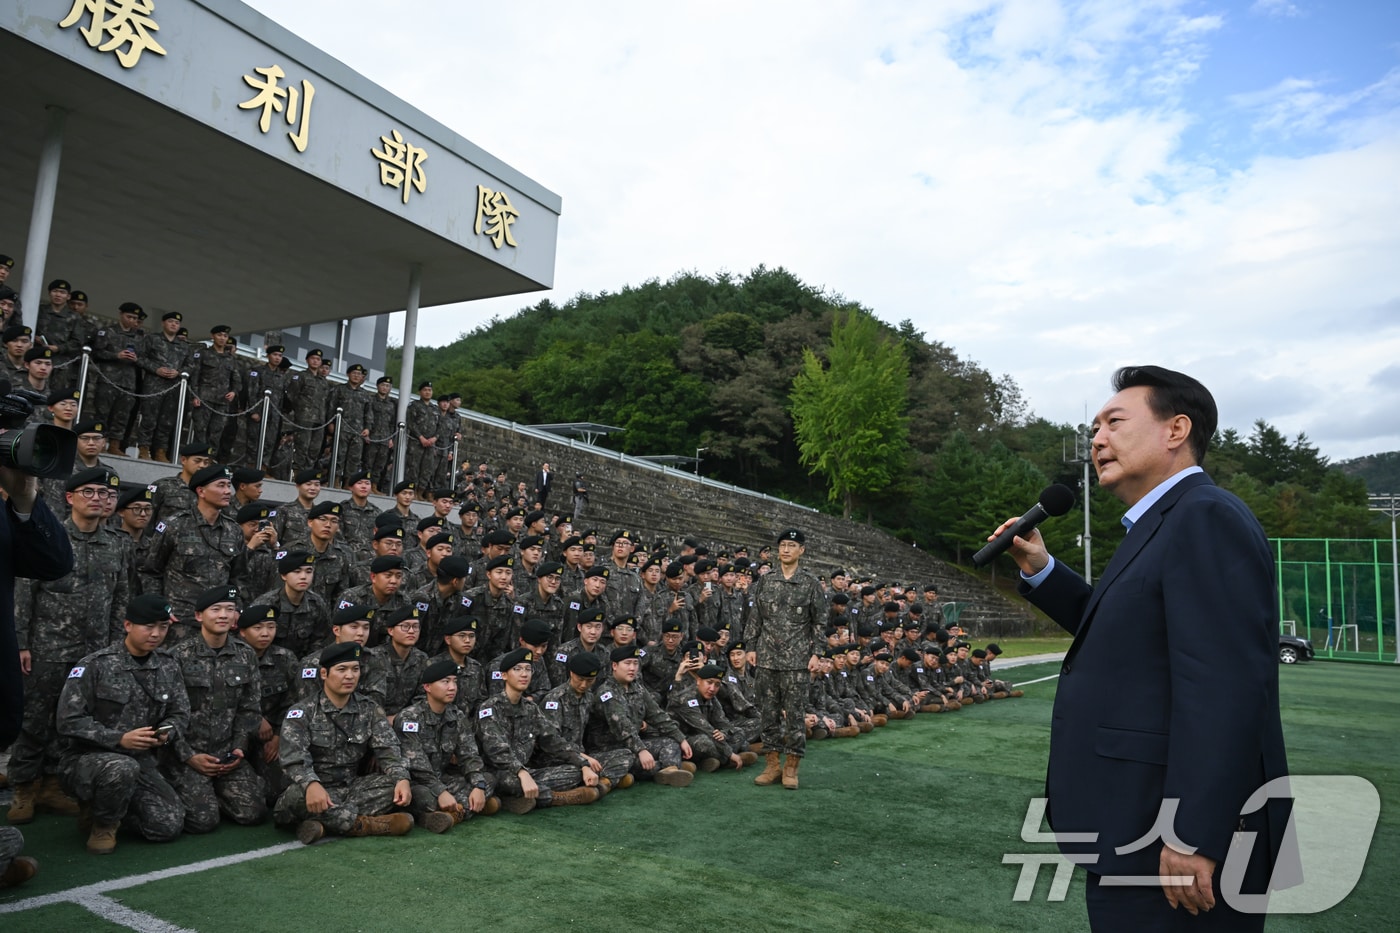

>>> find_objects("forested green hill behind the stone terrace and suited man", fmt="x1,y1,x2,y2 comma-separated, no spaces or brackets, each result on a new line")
388,266,1376,569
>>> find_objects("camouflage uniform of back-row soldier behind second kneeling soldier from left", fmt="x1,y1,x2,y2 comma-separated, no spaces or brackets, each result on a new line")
141,509,248,642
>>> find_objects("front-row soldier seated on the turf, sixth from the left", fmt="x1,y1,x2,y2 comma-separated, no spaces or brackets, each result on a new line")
584,644,694,787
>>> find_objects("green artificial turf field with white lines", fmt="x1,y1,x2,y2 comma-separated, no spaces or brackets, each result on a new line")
0,663,1400,933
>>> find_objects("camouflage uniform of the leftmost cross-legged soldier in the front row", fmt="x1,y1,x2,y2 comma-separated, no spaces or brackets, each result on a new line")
273,686,409,835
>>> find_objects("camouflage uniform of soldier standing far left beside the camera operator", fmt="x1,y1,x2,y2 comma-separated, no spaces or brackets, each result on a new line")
10,518,132,785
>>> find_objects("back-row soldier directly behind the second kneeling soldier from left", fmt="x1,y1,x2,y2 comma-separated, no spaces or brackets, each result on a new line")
141,464,248,642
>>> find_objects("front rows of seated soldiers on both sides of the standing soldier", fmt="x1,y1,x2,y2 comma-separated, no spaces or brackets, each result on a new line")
27,574,1009,853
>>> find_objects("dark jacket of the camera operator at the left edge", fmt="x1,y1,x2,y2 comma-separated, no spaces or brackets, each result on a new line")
0,496,73,748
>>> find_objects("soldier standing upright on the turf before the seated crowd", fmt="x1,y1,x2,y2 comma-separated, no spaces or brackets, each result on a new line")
746,528,826,790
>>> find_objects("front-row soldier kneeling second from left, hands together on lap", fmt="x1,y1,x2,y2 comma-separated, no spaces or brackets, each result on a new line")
162,587,267,834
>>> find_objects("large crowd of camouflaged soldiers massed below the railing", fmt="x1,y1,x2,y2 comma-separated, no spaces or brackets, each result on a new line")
0,443,1019,879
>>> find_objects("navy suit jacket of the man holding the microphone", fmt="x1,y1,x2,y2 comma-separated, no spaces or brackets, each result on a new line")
1022,474,1288,876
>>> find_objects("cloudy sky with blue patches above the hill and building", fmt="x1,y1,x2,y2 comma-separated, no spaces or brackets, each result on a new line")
251,0,1400,459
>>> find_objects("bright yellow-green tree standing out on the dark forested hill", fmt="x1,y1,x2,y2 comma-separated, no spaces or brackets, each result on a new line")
788,308,909,518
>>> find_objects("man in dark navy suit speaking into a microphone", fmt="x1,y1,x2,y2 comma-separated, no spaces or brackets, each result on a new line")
1002,366,1291,932
